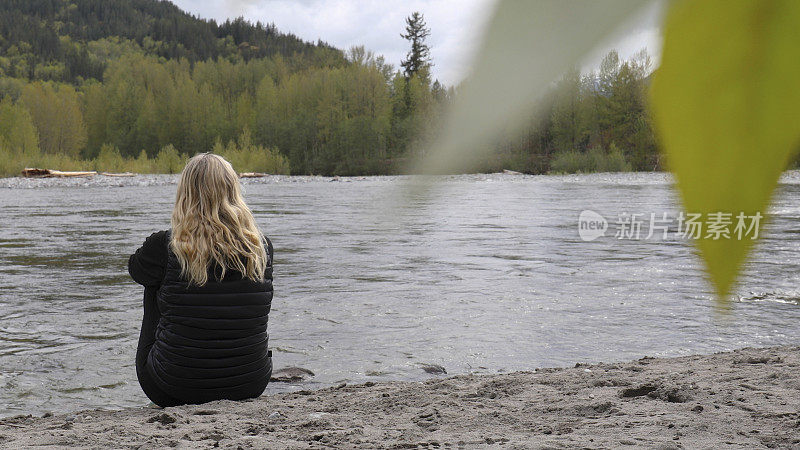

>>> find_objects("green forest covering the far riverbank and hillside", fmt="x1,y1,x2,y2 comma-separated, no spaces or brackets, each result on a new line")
0,0,662,175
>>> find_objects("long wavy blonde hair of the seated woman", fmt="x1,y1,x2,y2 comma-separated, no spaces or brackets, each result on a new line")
169,153,268,286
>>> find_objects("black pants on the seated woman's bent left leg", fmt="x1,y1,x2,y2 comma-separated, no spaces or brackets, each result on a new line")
136,287,185,408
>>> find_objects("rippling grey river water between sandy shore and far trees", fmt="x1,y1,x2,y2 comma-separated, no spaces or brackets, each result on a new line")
0,172,800,416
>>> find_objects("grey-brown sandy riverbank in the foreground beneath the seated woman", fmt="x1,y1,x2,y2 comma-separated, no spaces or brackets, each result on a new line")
0,347,800,449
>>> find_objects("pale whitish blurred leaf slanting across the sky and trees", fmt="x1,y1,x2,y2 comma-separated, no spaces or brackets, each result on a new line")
411,0,652,173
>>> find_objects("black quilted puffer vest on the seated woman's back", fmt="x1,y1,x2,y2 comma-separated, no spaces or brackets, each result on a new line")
133,232,273,403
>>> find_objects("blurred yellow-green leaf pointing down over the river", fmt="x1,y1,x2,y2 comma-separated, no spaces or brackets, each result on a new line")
651,0,800,303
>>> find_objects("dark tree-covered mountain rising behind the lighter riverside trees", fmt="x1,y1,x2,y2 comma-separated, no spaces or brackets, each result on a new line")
0,0,344,83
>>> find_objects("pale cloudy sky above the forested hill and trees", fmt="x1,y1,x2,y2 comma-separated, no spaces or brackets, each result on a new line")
172,0,661,86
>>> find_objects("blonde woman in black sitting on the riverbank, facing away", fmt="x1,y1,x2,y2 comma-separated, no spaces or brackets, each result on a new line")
128,153,272,407
